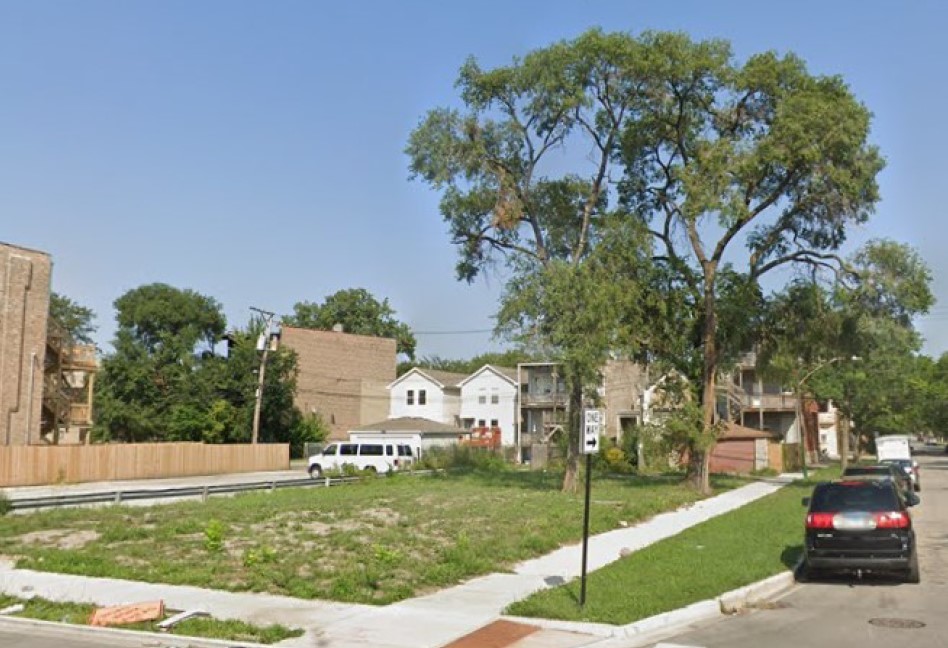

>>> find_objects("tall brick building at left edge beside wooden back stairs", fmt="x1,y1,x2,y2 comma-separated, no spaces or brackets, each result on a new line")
0,243,52,445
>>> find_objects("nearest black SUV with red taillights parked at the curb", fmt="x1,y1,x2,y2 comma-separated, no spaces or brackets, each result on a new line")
797,479,920,583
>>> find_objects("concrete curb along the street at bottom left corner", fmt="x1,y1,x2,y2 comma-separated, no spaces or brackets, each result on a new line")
0,615,277,648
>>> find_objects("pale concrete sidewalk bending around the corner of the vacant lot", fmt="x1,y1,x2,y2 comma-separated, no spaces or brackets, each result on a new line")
0,475,793,648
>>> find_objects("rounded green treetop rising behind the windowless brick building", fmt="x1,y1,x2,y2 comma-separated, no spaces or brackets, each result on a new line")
282,288,417,359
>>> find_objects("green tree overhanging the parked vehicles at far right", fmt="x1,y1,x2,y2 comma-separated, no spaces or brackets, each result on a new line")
758,240,933,462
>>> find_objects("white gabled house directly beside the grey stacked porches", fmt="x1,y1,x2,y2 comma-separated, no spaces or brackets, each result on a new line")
460,365,520,446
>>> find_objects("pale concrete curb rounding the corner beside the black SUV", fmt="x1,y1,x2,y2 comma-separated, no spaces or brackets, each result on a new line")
502,571,796,639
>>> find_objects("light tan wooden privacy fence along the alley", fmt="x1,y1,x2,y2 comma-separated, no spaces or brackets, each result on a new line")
0,443,290,487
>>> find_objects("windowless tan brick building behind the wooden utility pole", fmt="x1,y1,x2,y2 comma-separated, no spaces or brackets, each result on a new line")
280,326,396,440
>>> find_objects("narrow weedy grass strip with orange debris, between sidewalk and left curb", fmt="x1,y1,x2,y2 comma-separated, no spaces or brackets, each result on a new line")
0,594,303,644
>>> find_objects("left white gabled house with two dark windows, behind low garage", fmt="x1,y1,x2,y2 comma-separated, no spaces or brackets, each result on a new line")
388,367,467,426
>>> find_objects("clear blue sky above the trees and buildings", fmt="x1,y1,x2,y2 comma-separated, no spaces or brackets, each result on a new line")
0,0,948,358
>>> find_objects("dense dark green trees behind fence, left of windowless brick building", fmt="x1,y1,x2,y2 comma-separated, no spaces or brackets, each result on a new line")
93,284,306,454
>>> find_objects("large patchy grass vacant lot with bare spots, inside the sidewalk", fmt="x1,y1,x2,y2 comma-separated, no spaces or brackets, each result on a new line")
0,471,743,604
